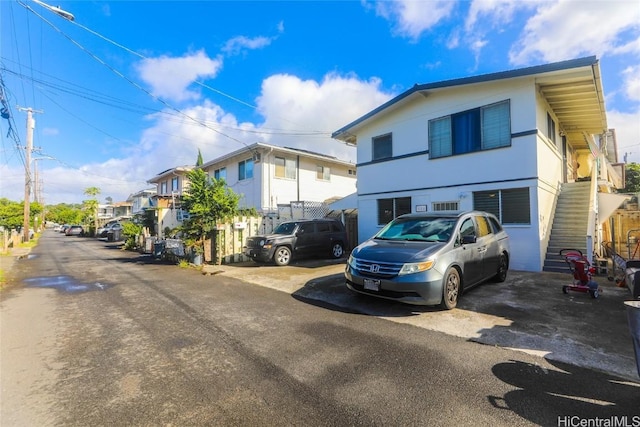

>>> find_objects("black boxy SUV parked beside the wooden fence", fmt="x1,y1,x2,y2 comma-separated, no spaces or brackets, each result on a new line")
244,219,348,265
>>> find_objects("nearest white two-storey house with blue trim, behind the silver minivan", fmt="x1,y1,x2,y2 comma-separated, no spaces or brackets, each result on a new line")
332,57,624,271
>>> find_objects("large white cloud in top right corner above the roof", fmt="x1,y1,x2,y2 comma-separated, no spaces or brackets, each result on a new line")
509,0,640,65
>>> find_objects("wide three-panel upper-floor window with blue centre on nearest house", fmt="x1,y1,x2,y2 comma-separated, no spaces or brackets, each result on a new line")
429,101,511,159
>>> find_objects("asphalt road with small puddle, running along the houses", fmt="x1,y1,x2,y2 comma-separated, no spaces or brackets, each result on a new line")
0,231,640,426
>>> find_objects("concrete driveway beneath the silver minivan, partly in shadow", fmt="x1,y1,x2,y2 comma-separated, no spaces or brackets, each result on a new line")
203,260,640,383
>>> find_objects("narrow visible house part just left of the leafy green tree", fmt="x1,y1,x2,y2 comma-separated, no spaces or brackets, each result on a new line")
148,166,194,238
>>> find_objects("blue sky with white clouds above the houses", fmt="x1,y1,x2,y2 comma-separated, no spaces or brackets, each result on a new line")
0,0,640,203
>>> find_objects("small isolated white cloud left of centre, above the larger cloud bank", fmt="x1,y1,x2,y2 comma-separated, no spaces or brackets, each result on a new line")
136,50,222,102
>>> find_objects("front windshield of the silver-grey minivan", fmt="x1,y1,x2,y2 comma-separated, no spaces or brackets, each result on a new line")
374,217,457,242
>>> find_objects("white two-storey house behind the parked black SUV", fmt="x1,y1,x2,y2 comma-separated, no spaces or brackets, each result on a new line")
202,143,356,218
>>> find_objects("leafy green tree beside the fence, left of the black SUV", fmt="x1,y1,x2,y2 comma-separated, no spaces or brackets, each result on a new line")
180,168,240,258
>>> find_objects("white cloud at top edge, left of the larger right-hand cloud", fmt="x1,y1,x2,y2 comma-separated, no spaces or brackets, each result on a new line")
375,0,456,40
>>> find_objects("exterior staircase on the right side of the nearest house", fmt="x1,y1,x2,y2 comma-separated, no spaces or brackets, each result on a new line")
542,181,591,273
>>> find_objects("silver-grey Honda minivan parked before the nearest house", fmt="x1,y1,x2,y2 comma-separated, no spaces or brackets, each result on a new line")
345,211,510,309
